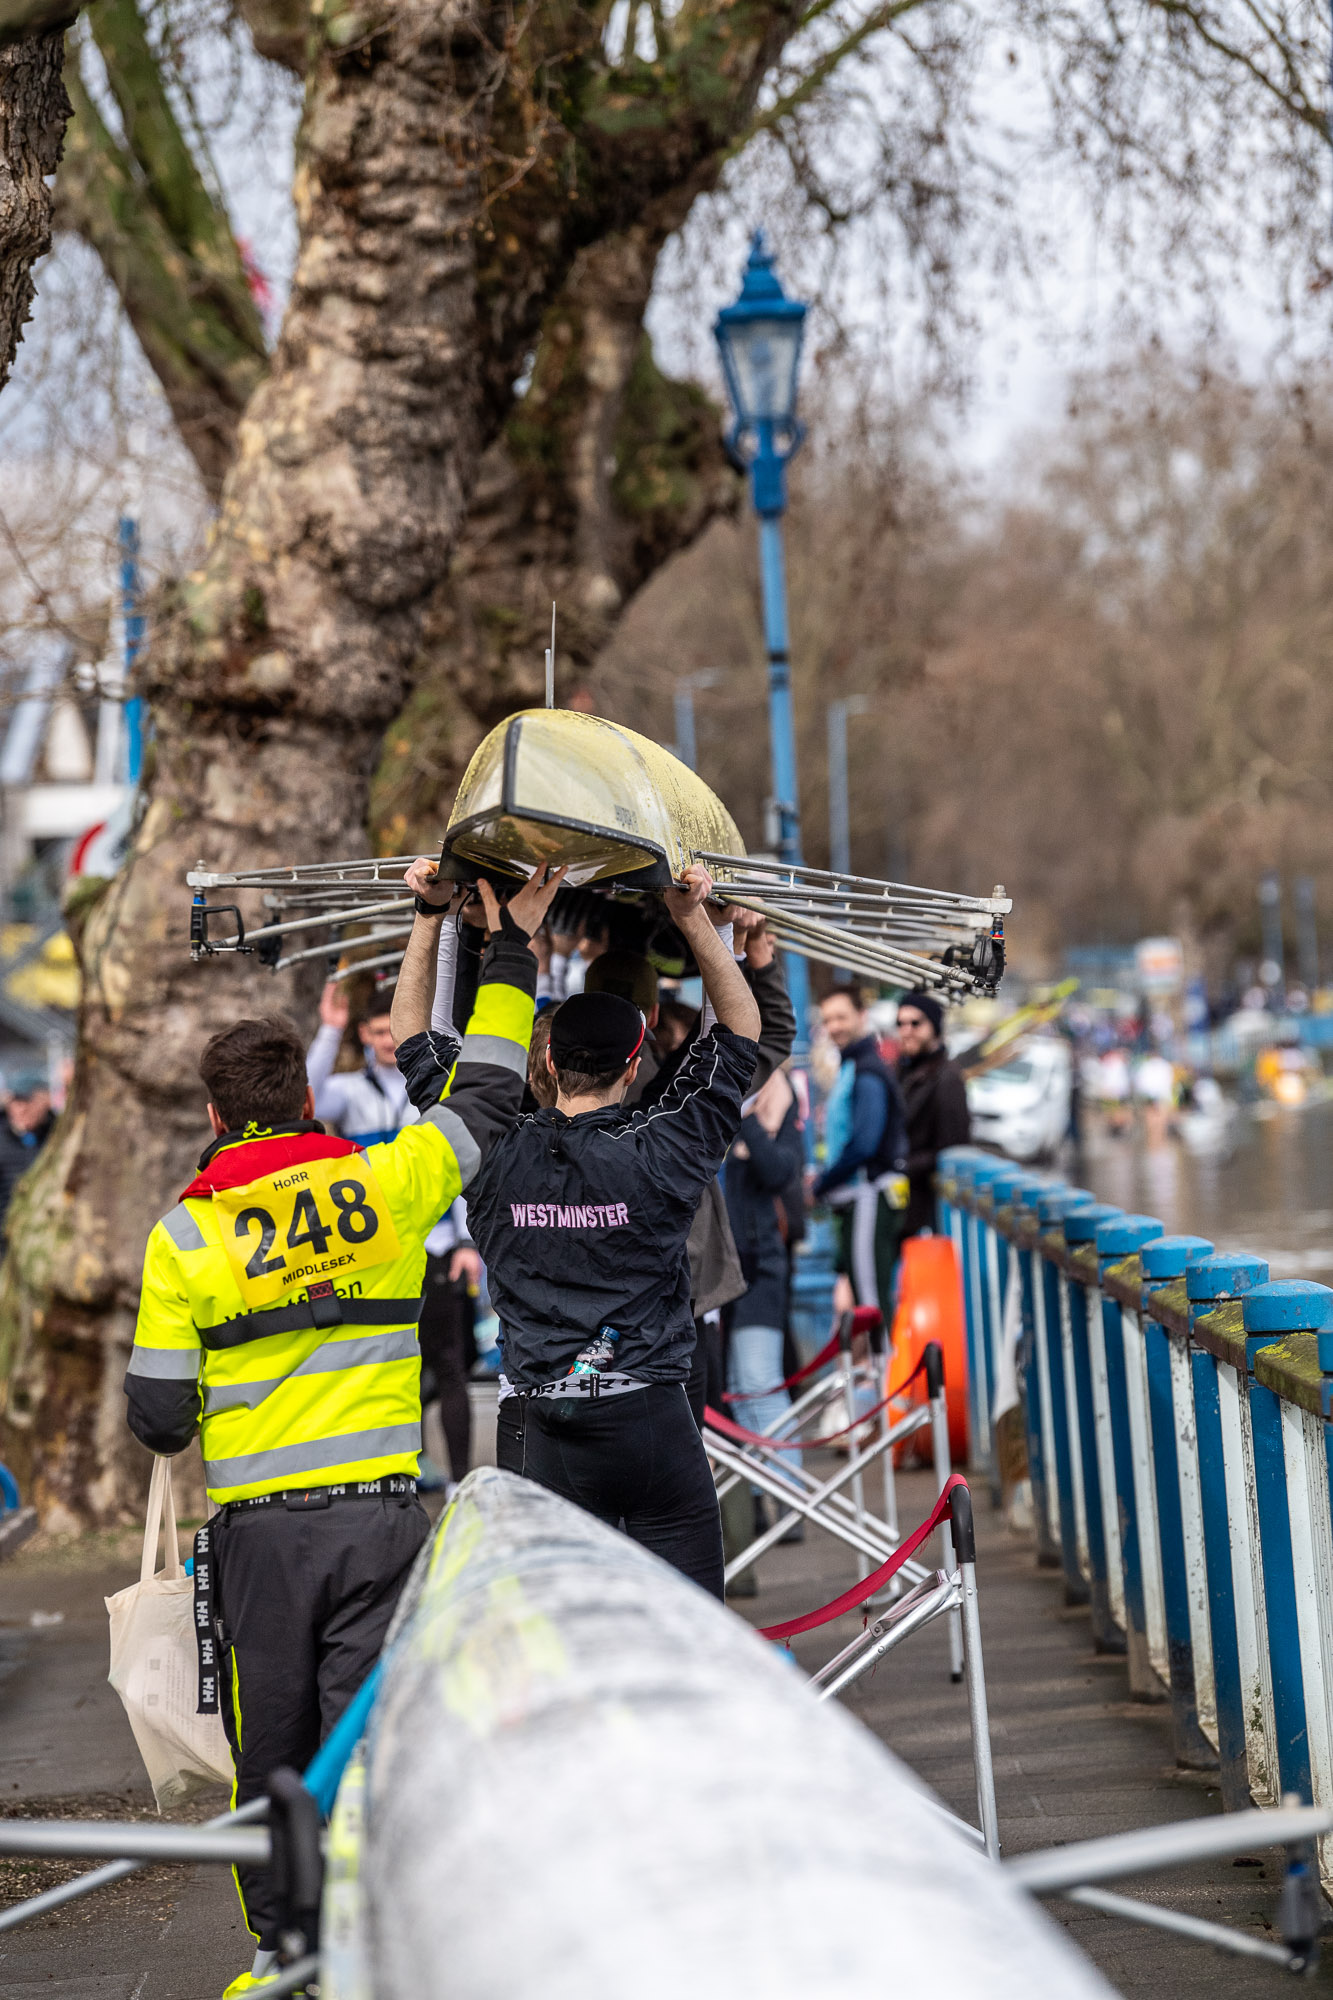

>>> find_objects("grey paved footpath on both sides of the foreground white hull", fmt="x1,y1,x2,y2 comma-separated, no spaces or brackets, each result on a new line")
0,1432,1333,2000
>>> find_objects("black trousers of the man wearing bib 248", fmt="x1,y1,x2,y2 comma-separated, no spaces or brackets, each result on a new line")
212,1494,430,1950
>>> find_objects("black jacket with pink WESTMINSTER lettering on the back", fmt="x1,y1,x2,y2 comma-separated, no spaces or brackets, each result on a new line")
468,1024,757,1388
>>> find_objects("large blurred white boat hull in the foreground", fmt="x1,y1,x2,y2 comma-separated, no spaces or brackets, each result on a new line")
320,1468,1111,2000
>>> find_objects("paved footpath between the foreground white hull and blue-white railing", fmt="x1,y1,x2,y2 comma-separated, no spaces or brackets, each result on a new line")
737,1472,1333,2000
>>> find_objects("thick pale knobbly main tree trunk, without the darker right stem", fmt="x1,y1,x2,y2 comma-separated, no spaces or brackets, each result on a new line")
0,0,502,1526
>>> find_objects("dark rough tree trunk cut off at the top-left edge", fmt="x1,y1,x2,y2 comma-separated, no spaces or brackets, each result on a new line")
0,28,70,388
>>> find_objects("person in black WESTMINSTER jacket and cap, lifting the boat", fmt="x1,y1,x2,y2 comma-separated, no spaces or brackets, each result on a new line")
400,864,759,1598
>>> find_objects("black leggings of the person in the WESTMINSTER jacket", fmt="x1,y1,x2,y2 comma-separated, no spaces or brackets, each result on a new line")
522,1382,723,1598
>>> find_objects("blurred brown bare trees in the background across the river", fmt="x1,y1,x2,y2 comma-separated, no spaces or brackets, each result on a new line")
594,348,1333,980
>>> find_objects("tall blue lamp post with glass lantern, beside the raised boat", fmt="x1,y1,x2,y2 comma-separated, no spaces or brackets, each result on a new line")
713,230,811,1056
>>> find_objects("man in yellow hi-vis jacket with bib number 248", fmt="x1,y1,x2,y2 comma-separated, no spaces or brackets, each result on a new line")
124,876,560,1996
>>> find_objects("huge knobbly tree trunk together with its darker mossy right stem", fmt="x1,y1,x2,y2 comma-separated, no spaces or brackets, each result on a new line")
0,0,795,1526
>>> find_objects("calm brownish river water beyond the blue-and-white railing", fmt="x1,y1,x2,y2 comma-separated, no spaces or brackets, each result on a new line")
1061,1102,1333,1284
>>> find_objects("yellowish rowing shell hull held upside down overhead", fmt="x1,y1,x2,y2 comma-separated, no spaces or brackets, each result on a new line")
440,708,745,888
